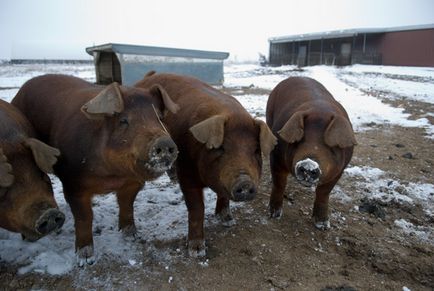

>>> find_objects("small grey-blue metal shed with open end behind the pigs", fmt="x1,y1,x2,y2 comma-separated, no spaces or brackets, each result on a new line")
86,43,229,86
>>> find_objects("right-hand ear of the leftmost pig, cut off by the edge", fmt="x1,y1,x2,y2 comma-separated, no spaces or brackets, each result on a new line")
25,138,60,173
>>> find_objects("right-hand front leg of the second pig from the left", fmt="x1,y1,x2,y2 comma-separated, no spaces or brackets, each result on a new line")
116,183,143,239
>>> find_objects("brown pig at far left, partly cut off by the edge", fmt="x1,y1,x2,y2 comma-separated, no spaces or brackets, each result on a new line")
0,100,65,241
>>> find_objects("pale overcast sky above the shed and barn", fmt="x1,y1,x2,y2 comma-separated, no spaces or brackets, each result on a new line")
0,0,434,60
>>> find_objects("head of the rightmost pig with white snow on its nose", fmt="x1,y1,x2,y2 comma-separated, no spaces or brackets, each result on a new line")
278,110,356,187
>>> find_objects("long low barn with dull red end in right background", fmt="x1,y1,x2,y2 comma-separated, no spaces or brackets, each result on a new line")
268,24,434,66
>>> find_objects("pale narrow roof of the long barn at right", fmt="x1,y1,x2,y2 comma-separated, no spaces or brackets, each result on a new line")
268,23,434,43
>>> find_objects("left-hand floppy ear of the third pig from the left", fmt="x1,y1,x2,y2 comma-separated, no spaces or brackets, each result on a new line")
190,115,226,149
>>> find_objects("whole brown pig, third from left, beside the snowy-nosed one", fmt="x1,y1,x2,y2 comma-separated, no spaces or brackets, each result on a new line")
136,72,276,256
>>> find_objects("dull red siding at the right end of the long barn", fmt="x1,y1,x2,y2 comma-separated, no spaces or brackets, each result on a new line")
379,29,434,67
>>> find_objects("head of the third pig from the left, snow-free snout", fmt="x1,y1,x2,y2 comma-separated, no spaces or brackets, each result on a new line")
190,115,276,201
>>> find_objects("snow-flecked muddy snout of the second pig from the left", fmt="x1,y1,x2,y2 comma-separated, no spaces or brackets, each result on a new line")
146,136,178,173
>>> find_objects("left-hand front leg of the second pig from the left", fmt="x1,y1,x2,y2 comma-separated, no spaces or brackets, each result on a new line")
65,191,95,267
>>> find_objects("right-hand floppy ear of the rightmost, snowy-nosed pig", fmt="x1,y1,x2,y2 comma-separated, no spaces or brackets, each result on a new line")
324,115,357,148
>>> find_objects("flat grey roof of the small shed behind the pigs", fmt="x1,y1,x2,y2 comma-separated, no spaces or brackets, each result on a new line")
86,43,229,60
